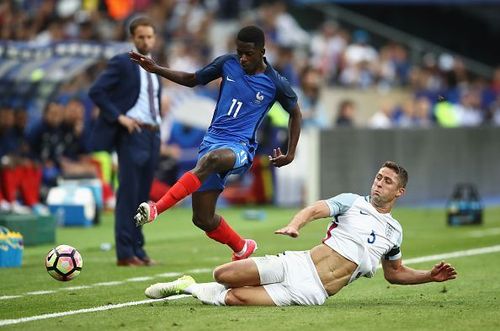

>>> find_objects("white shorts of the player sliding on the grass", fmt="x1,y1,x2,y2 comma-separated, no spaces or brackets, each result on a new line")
252,251,328,306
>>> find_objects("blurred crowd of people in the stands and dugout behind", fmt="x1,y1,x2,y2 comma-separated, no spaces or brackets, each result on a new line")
0,0,500,211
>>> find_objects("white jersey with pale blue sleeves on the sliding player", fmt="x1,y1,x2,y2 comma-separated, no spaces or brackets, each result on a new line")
323,193,403,283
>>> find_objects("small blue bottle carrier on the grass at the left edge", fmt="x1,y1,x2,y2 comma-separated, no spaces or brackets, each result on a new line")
0,226,24,268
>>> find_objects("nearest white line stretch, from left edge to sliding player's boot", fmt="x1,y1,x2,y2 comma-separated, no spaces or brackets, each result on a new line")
0,294,190,326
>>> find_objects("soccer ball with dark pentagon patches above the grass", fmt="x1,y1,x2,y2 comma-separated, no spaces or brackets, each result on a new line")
45,245,83,282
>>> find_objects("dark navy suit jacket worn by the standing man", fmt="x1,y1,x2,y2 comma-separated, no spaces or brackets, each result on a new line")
89,53,161,151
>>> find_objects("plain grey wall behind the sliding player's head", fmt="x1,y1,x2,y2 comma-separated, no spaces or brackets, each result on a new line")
314,127,500,205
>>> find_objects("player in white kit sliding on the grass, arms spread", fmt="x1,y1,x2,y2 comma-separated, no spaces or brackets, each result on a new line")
145,161,457,306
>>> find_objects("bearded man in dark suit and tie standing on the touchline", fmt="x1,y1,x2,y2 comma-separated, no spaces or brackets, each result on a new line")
89,17,161,266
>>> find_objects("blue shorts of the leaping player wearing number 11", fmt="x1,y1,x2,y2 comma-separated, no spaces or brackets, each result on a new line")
198,140,255,191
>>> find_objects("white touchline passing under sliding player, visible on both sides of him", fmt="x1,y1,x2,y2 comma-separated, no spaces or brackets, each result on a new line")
0,245,500,326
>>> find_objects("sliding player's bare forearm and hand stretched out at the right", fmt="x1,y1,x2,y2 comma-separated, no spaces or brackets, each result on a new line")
382,259,457,285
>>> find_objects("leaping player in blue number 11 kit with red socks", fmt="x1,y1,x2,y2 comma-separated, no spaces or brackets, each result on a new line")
130,26,302,260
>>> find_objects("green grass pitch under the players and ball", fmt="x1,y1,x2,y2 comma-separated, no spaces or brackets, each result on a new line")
0,207,500,331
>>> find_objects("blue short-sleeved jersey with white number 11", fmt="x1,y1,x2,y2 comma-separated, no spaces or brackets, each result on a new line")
196,54,297,148
